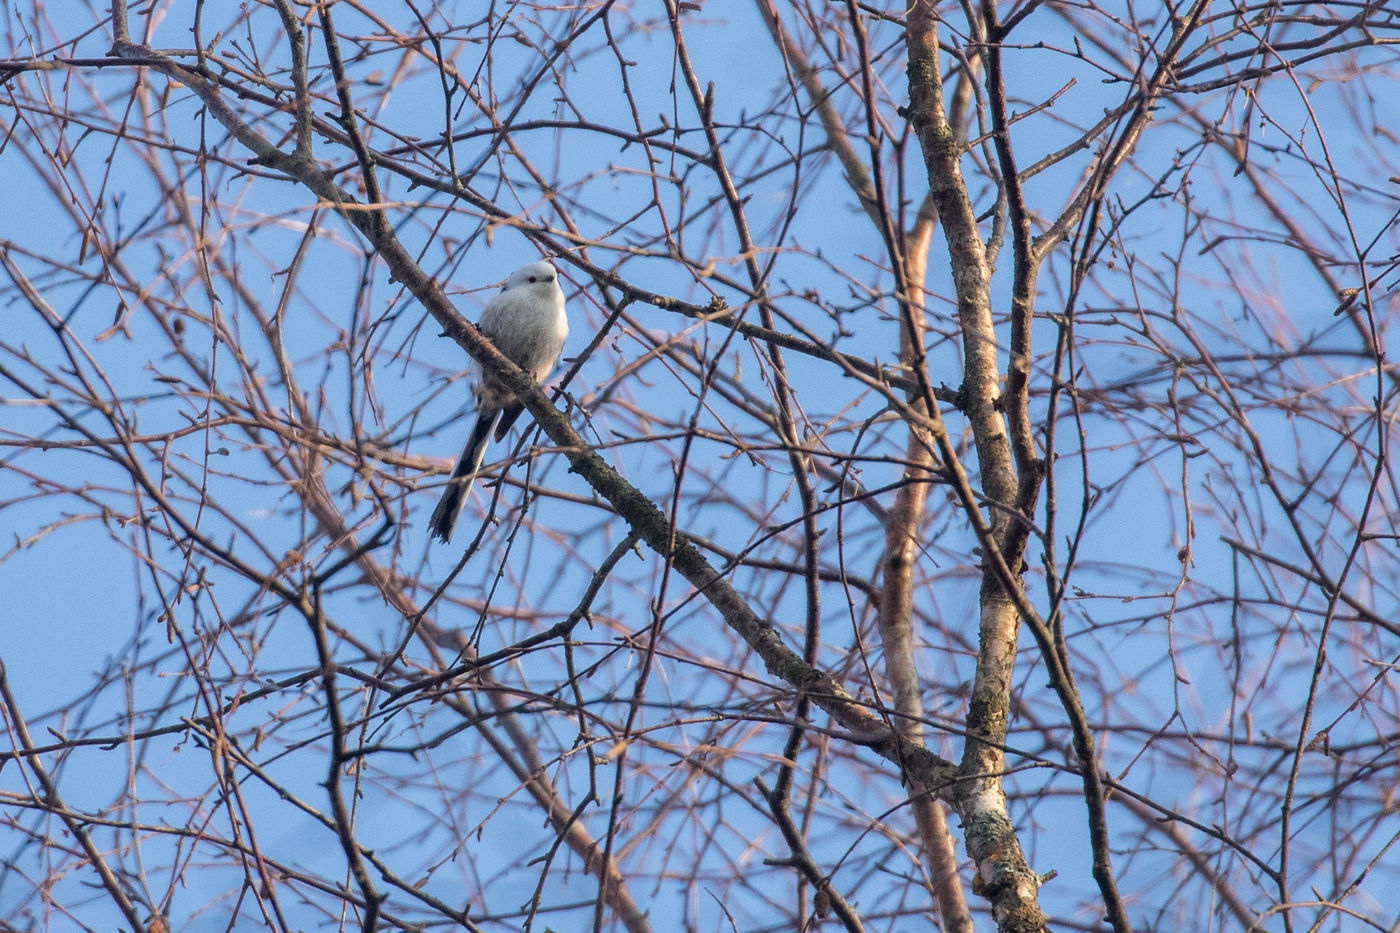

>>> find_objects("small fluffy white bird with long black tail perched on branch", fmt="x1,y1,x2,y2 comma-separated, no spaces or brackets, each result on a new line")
428,259,568,544
